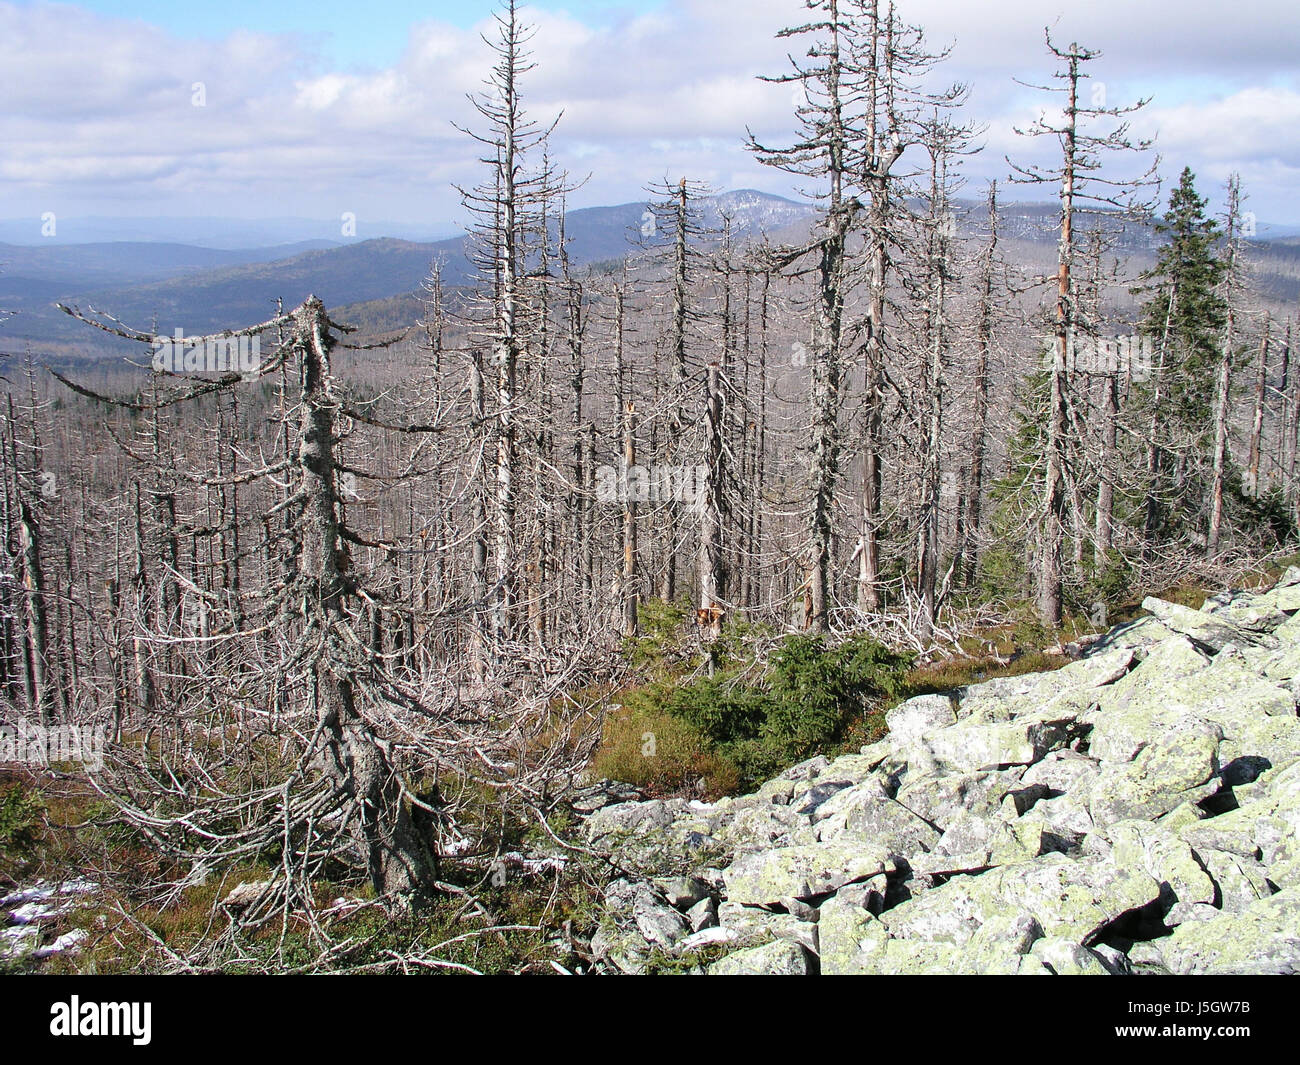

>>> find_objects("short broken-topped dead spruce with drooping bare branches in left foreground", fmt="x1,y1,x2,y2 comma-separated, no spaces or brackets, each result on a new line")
48,298,600,922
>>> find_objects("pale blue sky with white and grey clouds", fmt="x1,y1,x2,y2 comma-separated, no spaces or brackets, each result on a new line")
0,0,1300,237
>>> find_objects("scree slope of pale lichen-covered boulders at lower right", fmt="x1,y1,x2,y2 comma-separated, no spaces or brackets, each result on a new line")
585,568,1300,975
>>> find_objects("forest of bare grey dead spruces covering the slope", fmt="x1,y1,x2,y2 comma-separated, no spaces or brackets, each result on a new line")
0,0,1300,923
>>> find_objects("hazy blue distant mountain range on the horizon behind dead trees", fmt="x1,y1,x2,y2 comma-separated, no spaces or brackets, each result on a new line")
0,190,1300,354
